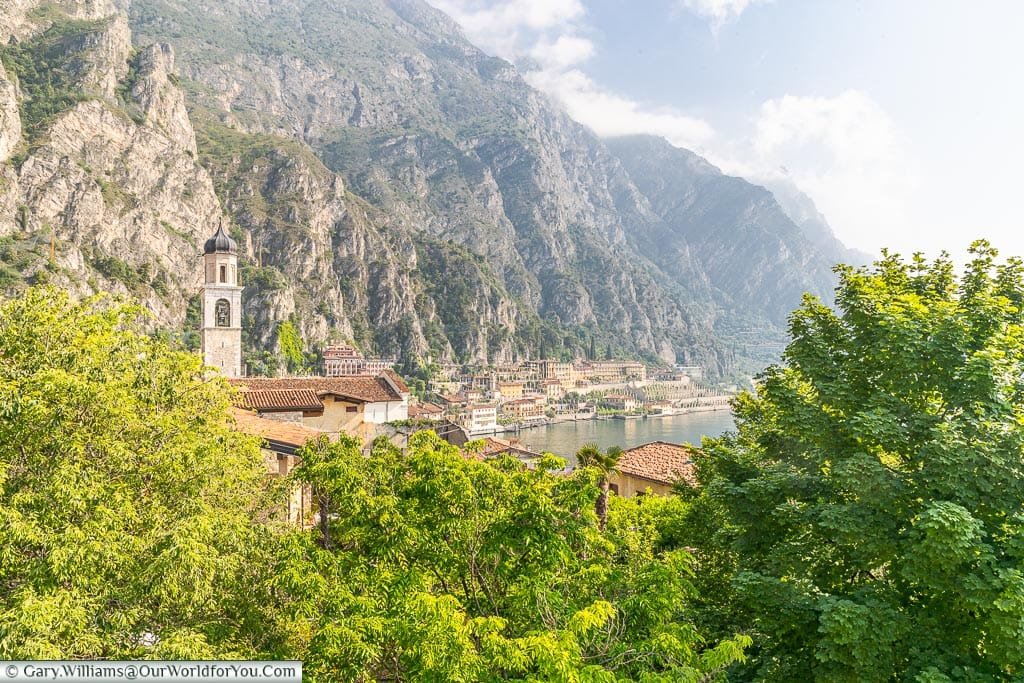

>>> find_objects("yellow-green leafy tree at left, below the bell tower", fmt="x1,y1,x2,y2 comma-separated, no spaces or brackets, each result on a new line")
0,288,280,658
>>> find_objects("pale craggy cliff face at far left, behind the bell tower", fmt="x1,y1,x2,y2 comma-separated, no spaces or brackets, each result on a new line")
0,2,225,331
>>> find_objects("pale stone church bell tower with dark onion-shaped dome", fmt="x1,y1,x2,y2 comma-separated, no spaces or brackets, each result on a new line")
200,226,242,377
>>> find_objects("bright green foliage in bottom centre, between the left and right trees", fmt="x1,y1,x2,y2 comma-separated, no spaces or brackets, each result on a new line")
274,432,749,681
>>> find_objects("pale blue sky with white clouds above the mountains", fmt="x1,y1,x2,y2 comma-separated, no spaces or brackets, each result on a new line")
428,0,1024,256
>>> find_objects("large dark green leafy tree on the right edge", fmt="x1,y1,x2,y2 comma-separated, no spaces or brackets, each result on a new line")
678,243,1024,681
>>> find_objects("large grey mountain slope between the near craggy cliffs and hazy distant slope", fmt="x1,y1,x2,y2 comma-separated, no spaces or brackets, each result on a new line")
132,0,719,365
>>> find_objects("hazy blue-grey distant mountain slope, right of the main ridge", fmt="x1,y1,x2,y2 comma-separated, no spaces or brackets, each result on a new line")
607,135,843,326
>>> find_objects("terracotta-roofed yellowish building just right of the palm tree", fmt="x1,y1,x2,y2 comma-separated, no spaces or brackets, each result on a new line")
608,441,696,498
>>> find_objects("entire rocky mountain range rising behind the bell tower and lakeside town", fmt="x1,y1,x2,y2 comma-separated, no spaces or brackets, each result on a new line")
0,0,864,376
